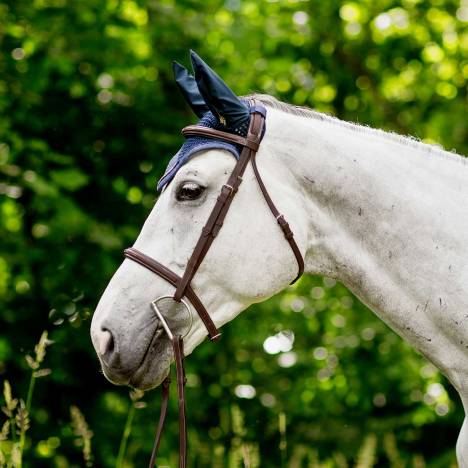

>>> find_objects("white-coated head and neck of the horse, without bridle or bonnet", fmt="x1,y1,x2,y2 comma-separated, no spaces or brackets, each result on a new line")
91,95,468,468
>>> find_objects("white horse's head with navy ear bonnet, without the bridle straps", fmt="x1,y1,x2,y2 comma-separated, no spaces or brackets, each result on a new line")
91,52,306,389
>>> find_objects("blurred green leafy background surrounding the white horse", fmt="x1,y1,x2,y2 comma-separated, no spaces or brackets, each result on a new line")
0,0,468,468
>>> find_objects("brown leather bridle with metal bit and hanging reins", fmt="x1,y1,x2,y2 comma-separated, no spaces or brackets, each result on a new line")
124,100,304,468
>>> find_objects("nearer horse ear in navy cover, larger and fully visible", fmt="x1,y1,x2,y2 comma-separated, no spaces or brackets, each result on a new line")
190,50,250,130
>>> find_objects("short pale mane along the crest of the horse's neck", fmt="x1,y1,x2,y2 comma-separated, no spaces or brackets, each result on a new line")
246,93,468,165
